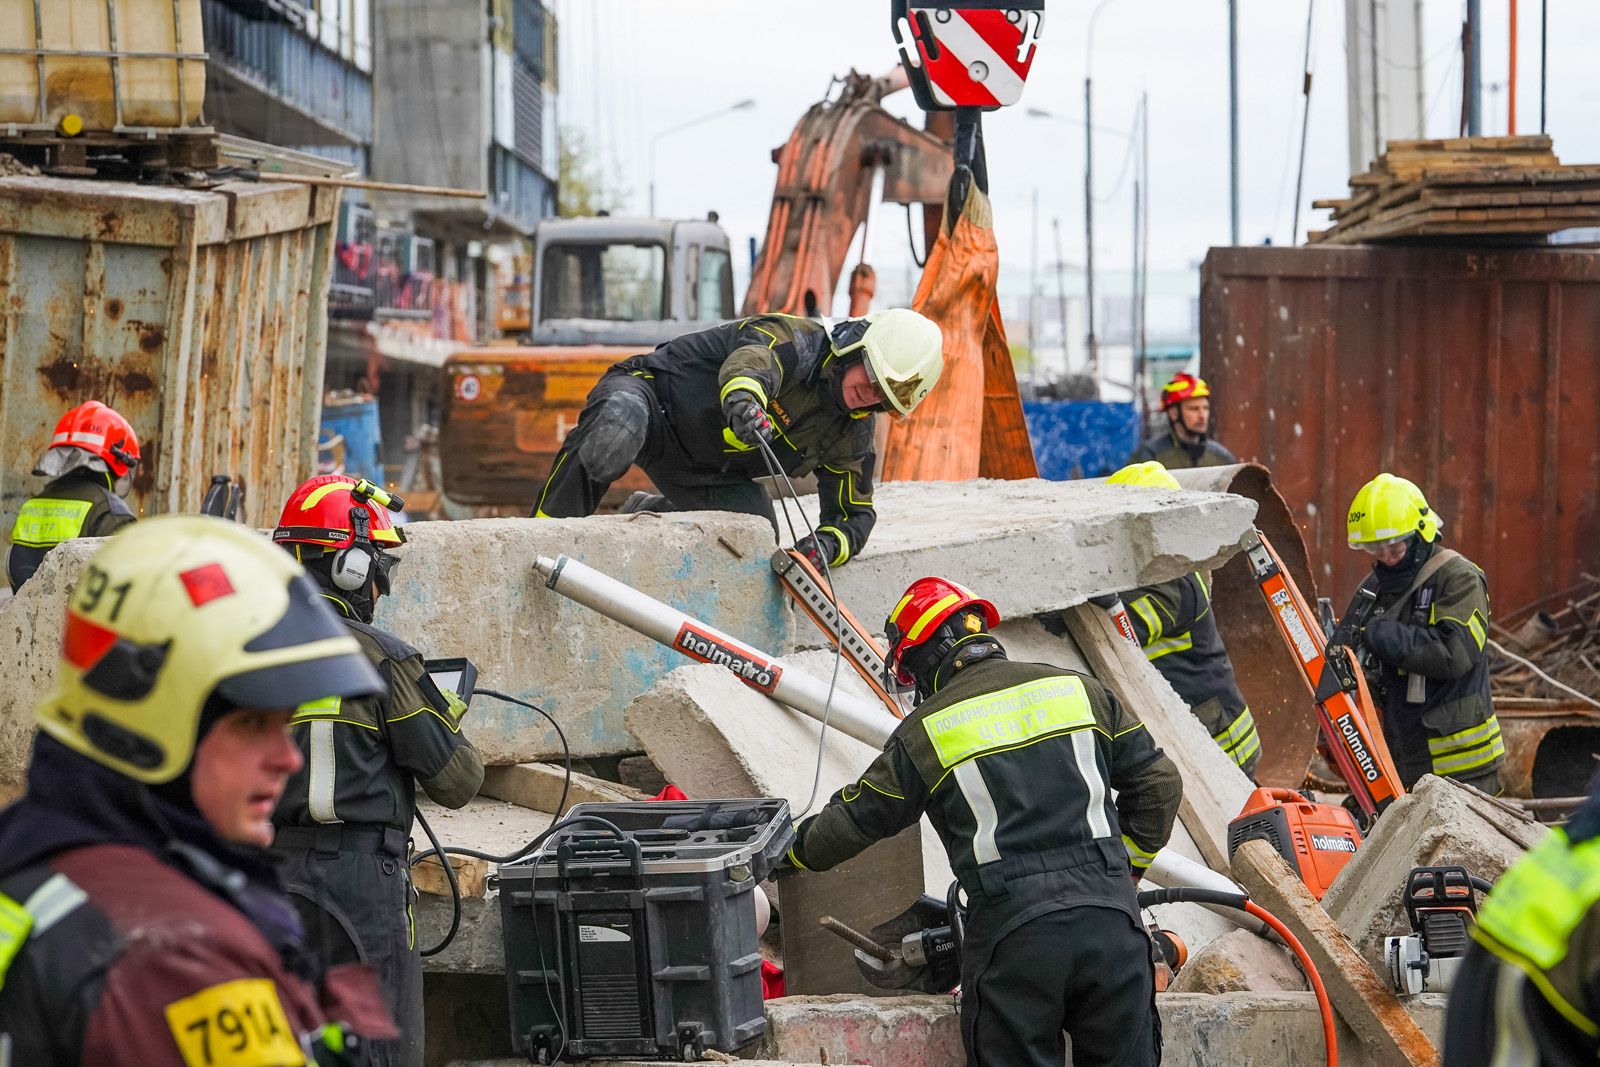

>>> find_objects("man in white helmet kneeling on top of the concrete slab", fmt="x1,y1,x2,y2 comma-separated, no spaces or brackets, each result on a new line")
533,307,944,566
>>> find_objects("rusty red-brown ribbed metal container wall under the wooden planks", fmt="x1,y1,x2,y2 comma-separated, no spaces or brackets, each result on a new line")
1200,246,1600,620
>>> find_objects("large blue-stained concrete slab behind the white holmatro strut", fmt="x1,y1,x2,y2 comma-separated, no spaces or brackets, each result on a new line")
0,512,794,785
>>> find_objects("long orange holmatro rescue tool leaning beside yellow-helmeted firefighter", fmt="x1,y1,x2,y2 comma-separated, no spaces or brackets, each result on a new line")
1245,530,1405,819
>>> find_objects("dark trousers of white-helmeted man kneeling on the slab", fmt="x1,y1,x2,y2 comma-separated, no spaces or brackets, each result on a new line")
533,371,778,530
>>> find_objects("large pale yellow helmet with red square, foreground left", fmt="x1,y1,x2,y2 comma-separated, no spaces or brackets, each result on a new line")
37,515,384,785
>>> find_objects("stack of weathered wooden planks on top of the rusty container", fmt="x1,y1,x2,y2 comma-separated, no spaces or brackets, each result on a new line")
1307,134,1600,245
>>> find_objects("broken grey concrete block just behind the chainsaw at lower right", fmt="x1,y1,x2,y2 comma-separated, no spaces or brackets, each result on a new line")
1322,774,1547,973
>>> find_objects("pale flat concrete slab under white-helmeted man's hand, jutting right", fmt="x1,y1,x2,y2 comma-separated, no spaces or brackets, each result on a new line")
803,478,1256,637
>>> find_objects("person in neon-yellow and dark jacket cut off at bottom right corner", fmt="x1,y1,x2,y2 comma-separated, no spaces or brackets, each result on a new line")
1443,780,1600,1067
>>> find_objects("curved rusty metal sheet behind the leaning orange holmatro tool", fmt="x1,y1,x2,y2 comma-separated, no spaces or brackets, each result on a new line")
1173,464,1317,789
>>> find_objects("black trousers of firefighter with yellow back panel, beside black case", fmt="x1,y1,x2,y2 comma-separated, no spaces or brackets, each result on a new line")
962,905,1162,1067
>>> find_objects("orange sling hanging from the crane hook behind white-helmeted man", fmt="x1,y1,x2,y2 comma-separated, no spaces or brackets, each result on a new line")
883,182,1038,482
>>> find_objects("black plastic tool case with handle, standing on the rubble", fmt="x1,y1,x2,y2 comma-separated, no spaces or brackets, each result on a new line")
499,800,794,1062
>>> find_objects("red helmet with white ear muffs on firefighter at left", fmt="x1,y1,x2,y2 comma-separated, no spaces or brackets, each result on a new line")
272,474,405,593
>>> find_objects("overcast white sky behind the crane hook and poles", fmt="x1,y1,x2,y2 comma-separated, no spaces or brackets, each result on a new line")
554,0,1600,287
